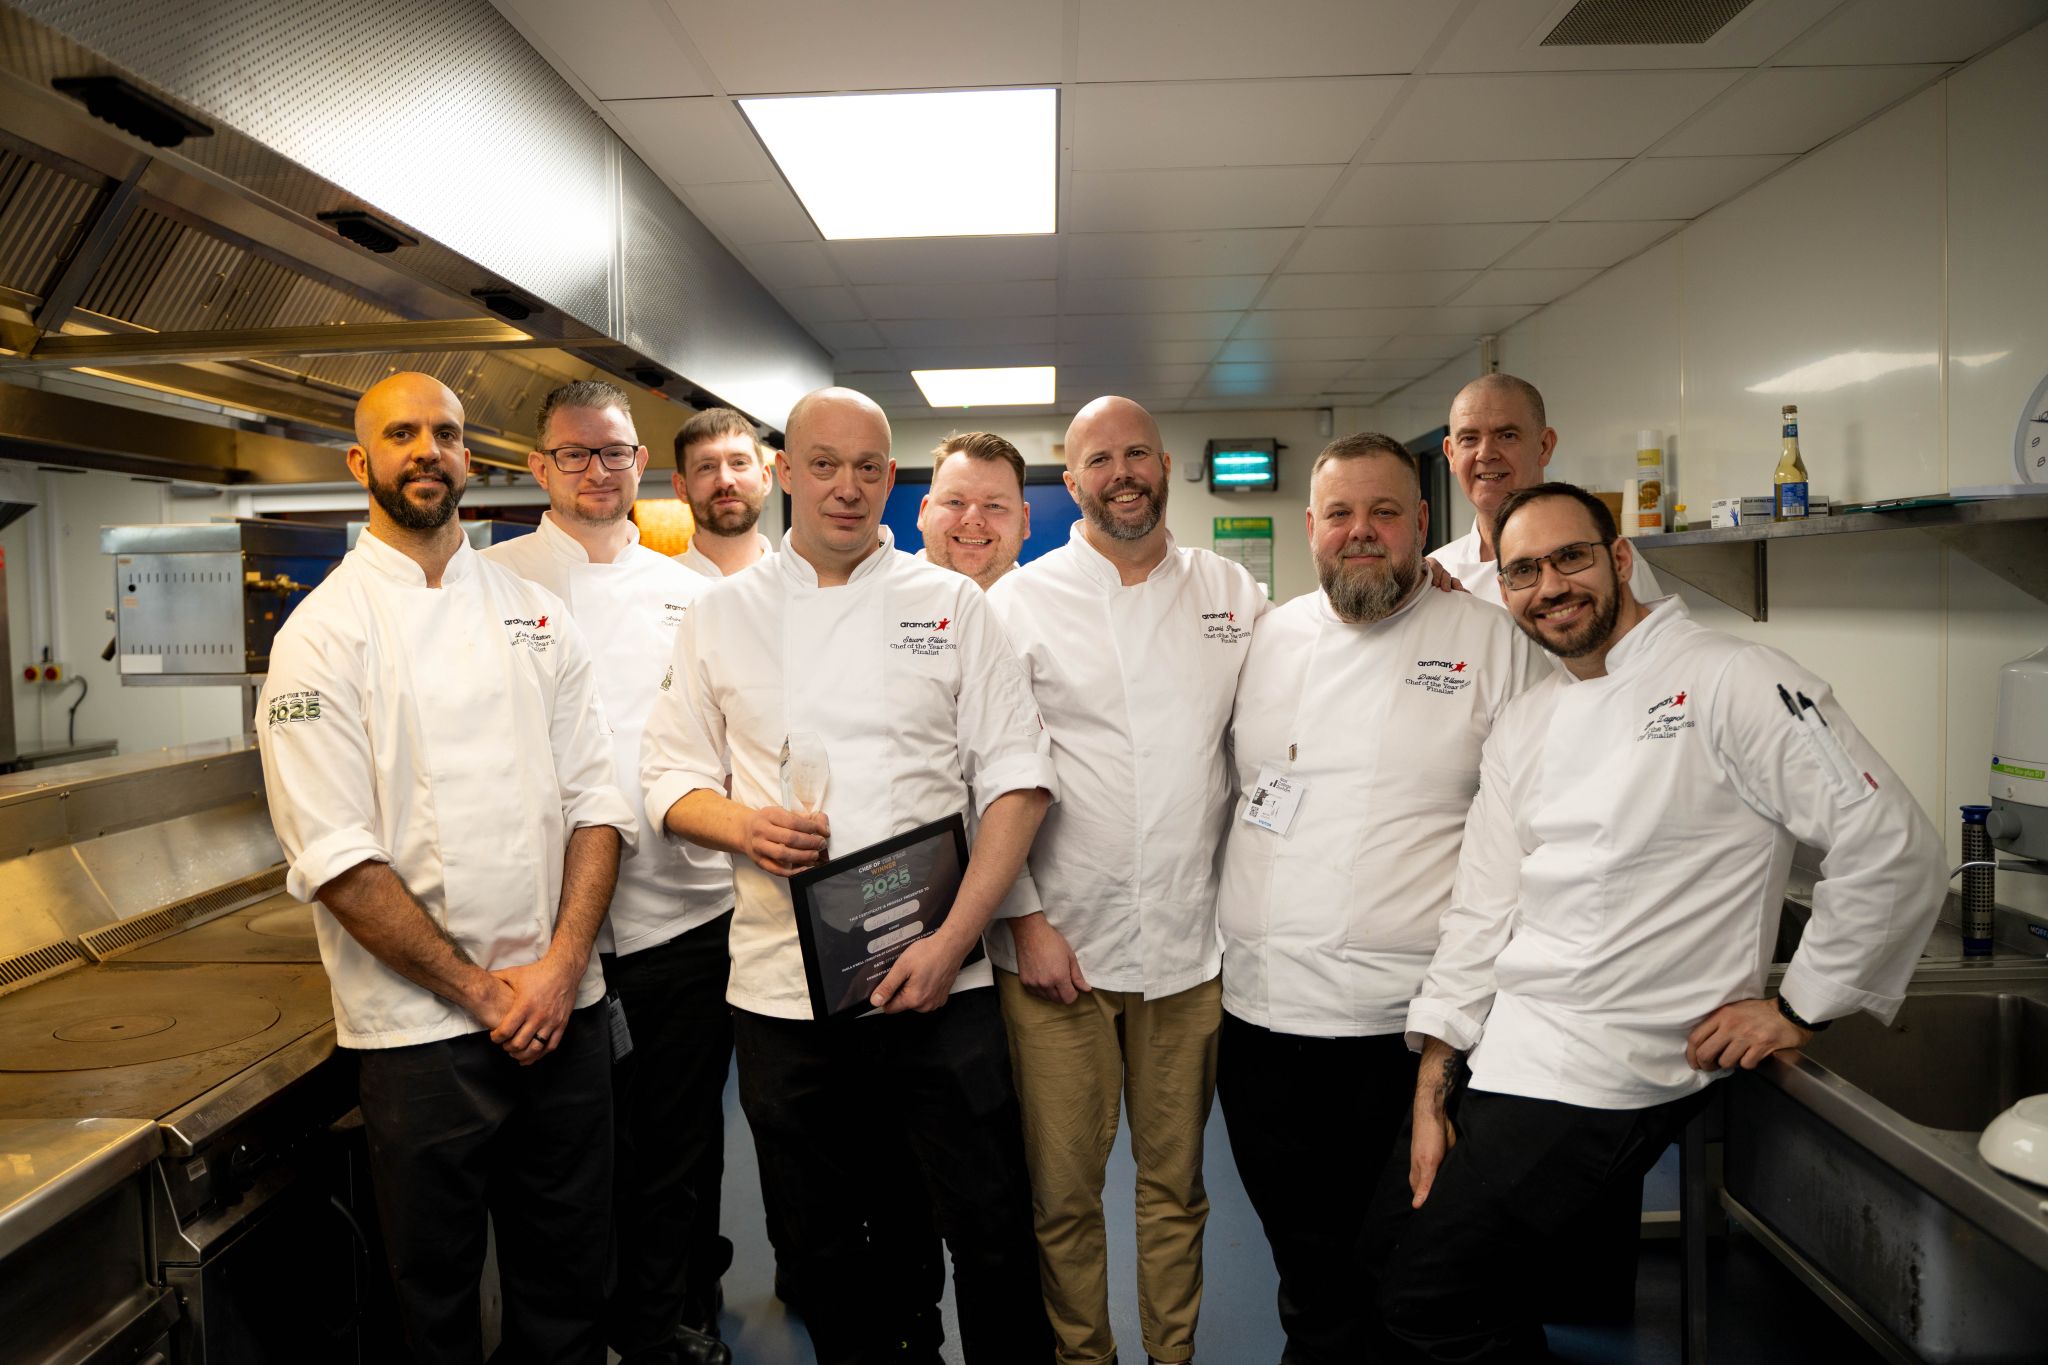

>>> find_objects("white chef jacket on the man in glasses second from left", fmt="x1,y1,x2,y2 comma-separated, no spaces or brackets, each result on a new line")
483,512,733,954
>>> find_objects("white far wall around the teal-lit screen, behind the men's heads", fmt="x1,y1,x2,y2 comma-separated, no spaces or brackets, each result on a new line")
889,409,1358,602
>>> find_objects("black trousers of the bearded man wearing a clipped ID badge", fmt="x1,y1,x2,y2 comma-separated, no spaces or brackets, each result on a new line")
1217,1011,1415,1365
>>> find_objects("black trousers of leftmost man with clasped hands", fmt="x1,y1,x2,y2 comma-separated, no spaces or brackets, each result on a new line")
358,1005,612,1365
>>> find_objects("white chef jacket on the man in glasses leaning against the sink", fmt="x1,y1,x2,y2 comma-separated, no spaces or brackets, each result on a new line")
1409,598,1944,1109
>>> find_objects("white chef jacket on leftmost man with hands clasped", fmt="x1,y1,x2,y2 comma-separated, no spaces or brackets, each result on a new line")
258,532,637,1048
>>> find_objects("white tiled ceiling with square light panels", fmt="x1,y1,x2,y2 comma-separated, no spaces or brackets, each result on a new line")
494,0,2048,415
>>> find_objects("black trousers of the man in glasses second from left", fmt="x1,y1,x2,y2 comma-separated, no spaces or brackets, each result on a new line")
604,911,733,1357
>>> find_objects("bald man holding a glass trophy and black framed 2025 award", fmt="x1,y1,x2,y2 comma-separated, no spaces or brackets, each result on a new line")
641,389,1055,1365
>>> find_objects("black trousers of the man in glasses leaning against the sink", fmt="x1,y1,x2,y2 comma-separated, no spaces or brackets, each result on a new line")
1360,1091,1708,1361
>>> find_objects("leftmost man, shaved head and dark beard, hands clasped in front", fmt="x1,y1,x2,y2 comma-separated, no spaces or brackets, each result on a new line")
258,372,639,1365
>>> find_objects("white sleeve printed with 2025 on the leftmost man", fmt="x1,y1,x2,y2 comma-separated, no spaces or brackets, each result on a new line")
256,620,391,900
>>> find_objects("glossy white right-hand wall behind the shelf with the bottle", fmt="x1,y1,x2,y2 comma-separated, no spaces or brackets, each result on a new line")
1366,27,2048,909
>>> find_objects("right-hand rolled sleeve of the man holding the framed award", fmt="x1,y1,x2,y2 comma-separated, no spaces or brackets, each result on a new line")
954,589,1059,814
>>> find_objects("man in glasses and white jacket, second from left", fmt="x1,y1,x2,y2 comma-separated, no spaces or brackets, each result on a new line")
483,379,733,1365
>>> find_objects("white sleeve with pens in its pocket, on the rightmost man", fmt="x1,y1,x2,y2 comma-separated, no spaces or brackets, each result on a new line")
1710,647,1946,1023
